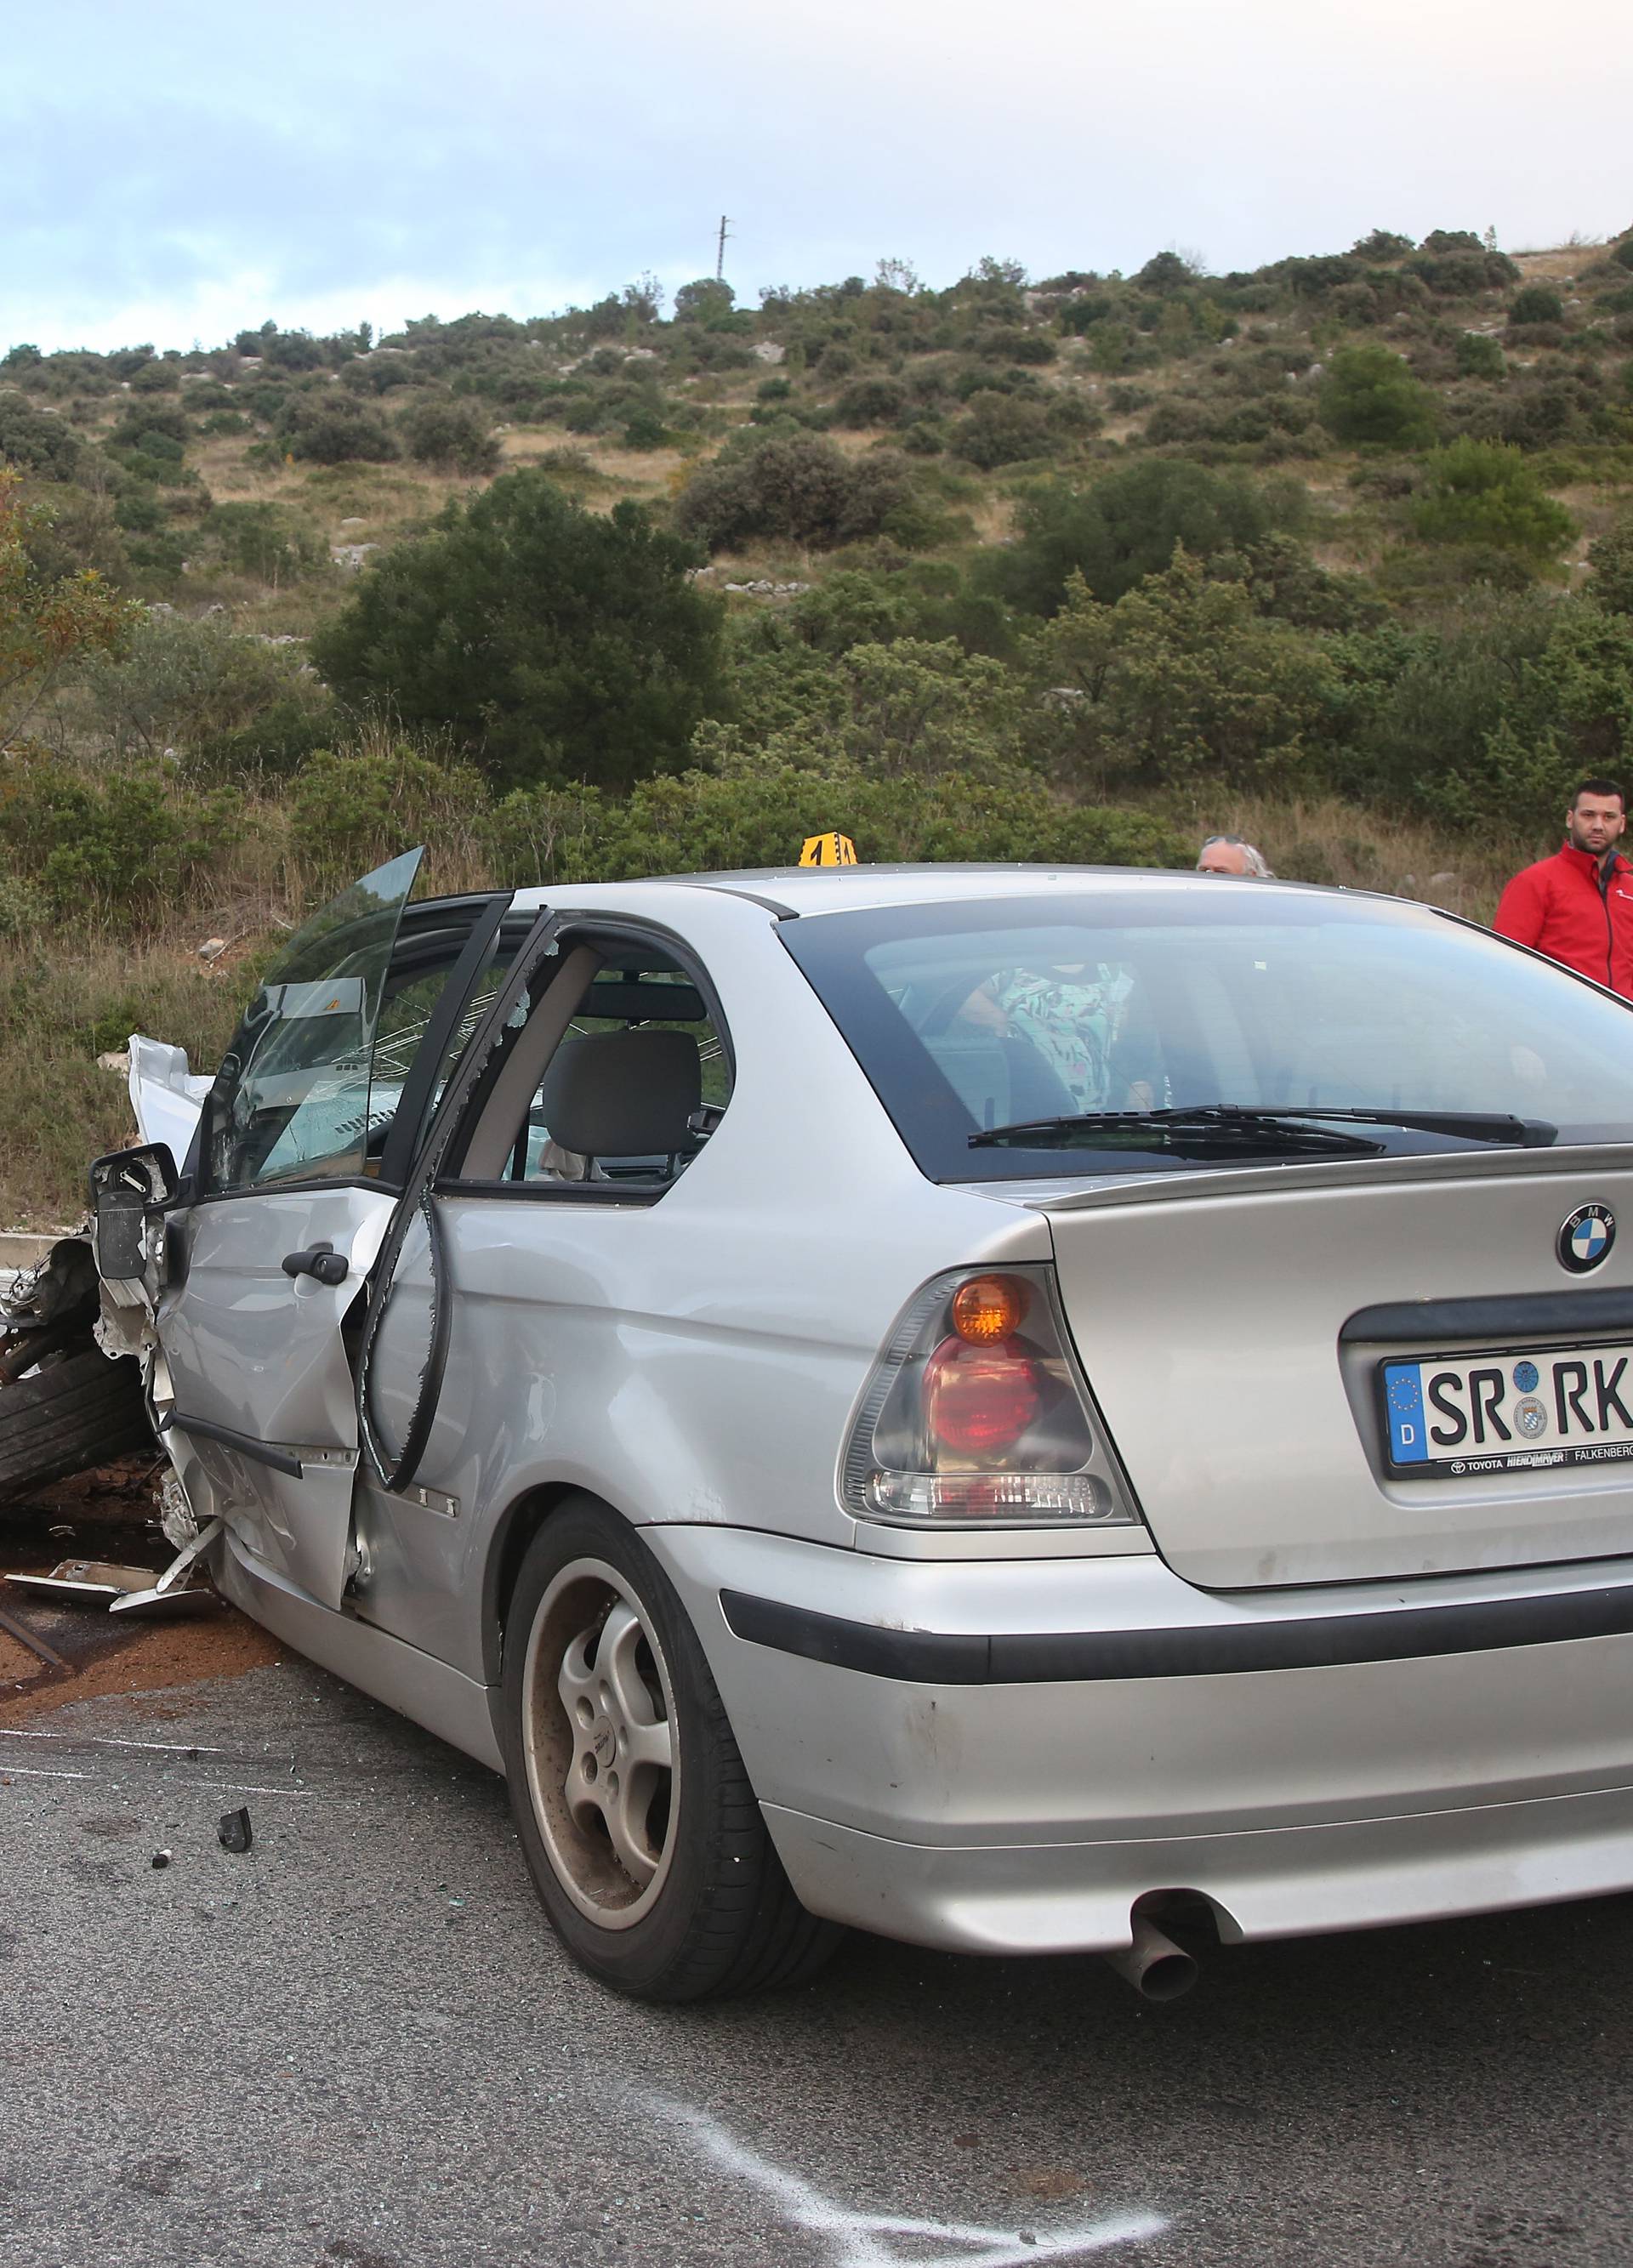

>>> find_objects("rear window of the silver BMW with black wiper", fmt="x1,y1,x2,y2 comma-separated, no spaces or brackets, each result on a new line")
780,882,1633,1182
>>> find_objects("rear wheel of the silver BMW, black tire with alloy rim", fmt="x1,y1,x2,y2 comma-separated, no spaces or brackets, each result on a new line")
504,1497,844,2003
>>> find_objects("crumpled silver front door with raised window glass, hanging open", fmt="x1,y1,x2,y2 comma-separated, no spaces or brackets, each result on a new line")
152,850,508,1608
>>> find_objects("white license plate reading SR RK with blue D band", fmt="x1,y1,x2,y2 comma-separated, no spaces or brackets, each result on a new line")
1379,1343,1633,1479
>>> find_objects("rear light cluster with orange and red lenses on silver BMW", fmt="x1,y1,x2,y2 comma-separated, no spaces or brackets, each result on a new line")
844,1265,1139,1526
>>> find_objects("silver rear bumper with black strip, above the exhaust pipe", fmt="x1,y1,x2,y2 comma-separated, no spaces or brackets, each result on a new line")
644,1529,1633,1953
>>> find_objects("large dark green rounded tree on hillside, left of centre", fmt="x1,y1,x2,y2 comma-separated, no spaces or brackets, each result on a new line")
313,469,719,787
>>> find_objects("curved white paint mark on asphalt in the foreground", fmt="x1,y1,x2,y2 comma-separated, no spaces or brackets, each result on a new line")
640,2095,1168,2268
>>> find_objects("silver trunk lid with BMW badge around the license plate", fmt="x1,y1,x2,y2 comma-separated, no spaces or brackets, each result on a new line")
1030,1148,1633,1590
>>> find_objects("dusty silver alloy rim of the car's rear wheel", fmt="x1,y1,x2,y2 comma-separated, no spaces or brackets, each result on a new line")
521,1558,680,1930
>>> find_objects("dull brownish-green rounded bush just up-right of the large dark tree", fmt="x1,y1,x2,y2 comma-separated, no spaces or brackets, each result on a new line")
676,433,908,551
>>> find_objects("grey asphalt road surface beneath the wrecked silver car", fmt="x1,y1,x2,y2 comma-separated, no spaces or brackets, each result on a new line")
0,1596,1633,2268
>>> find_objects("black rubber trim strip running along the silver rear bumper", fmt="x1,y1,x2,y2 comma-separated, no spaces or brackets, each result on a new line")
721,1583,1633,1685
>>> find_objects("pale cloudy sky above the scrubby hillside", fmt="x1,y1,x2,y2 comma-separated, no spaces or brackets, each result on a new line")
0,0,1633,347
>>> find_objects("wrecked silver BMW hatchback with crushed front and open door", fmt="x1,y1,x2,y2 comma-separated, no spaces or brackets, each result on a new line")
93,853,1633,2000
